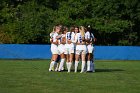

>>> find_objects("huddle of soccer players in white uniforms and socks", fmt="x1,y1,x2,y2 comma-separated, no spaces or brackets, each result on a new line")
49,25,96,73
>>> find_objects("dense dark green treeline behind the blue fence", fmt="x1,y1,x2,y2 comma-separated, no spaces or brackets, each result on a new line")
0,0,140,45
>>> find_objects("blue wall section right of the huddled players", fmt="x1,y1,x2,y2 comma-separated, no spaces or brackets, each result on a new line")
95,46,140,60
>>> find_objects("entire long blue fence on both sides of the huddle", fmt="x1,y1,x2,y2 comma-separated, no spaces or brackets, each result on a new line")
0,44,140,60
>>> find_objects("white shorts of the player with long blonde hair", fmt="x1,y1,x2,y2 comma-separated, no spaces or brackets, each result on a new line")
76,45,87,55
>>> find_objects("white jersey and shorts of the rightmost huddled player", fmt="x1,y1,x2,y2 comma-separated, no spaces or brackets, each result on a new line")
85,31,94,53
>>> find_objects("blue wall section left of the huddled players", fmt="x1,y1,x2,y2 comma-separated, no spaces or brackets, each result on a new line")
0,44,51,59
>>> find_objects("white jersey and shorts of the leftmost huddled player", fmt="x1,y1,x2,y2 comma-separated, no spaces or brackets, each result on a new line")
51,32,59,54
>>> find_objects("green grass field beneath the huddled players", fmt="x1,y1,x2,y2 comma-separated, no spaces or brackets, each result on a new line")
0,60,140,93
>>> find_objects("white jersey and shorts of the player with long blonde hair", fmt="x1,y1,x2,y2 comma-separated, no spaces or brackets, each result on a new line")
75,33,87,55
